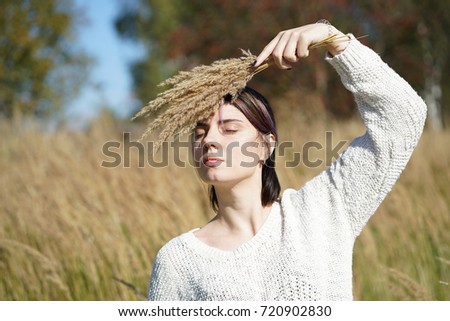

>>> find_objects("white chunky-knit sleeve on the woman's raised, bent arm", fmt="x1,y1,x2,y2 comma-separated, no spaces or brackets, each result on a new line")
302,40,426,237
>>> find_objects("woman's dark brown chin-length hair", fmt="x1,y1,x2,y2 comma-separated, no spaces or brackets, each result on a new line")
209,86,281,212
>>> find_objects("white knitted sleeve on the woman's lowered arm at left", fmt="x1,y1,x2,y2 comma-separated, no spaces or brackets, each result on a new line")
147,247,181,301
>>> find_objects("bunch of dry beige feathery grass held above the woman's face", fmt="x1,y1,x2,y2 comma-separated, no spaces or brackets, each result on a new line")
132,50,268,151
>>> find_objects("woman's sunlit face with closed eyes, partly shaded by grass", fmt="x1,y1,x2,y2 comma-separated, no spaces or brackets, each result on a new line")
193,103,266,186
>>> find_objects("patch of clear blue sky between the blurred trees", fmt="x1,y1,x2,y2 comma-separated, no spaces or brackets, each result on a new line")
67,0,140,123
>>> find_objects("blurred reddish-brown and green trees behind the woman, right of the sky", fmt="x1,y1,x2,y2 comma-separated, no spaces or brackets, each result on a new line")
116,0,450,125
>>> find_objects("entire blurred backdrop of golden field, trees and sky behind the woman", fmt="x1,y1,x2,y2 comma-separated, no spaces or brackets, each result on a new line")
0,0,450,300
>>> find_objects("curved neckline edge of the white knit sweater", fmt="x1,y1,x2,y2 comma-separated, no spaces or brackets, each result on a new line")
183,201,280,258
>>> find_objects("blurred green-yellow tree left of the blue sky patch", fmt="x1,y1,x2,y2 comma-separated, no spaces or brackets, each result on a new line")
0,0,89,117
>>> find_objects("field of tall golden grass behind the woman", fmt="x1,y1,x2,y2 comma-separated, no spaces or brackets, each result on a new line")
0,113,450,300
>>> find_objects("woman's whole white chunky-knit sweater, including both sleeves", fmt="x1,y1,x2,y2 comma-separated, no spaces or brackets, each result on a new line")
148,40,426,301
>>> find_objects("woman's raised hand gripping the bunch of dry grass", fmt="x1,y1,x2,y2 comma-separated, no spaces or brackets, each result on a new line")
255,23,348,69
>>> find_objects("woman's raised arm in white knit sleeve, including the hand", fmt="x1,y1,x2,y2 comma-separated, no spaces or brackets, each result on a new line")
257,24,426,237
